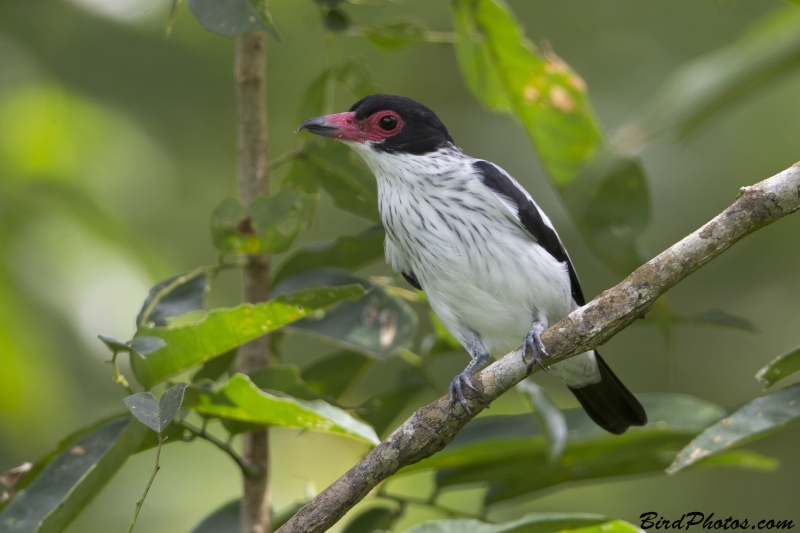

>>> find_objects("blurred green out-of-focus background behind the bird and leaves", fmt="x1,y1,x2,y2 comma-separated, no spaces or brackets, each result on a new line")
0,0,800,533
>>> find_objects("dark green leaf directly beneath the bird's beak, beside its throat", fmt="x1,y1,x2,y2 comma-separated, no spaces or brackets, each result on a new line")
283,139,380,222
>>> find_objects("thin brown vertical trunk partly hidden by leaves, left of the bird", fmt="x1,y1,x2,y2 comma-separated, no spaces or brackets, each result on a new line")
235,33,270,533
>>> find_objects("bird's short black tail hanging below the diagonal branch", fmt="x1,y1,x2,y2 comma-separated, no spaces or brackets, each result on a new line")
569,351,647,435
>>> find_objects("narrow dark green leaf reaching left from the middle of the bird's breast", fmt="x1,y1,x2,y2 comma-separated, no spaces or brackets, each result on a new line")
273,226,385,284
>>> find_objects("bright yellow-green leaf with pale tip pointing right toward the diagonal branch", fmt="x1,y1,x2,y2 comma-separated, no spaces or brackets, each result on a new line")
185,374,380,444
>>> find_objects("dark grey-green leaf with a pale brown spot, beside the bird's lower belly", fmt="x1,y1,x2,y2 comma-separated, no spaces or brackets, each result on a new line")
272,268,418,358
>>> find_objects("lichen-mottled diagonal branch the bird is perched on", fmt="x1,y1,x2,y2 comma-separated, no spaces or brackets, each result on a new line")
277,163,800,533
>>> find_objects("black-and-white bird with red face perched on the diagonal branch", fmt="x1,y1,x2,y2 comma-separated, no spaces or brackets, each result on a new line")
298,94,647,434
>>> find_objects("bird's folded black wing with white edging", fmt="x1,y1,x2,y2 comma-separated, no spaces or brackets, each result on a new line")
473,161,586,306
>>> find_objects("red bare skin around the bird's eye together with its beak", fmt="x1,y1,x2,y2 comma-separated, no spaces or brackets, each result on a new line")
300,111,403,143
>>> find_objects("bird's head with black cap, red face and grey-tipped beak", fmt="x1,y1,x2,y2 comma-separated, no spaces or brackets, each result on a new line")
300,94,454,155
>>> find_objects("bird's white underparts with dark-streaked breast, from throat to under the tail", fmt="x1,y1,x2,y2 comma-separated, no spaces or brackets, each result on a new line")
348,143,598,386
